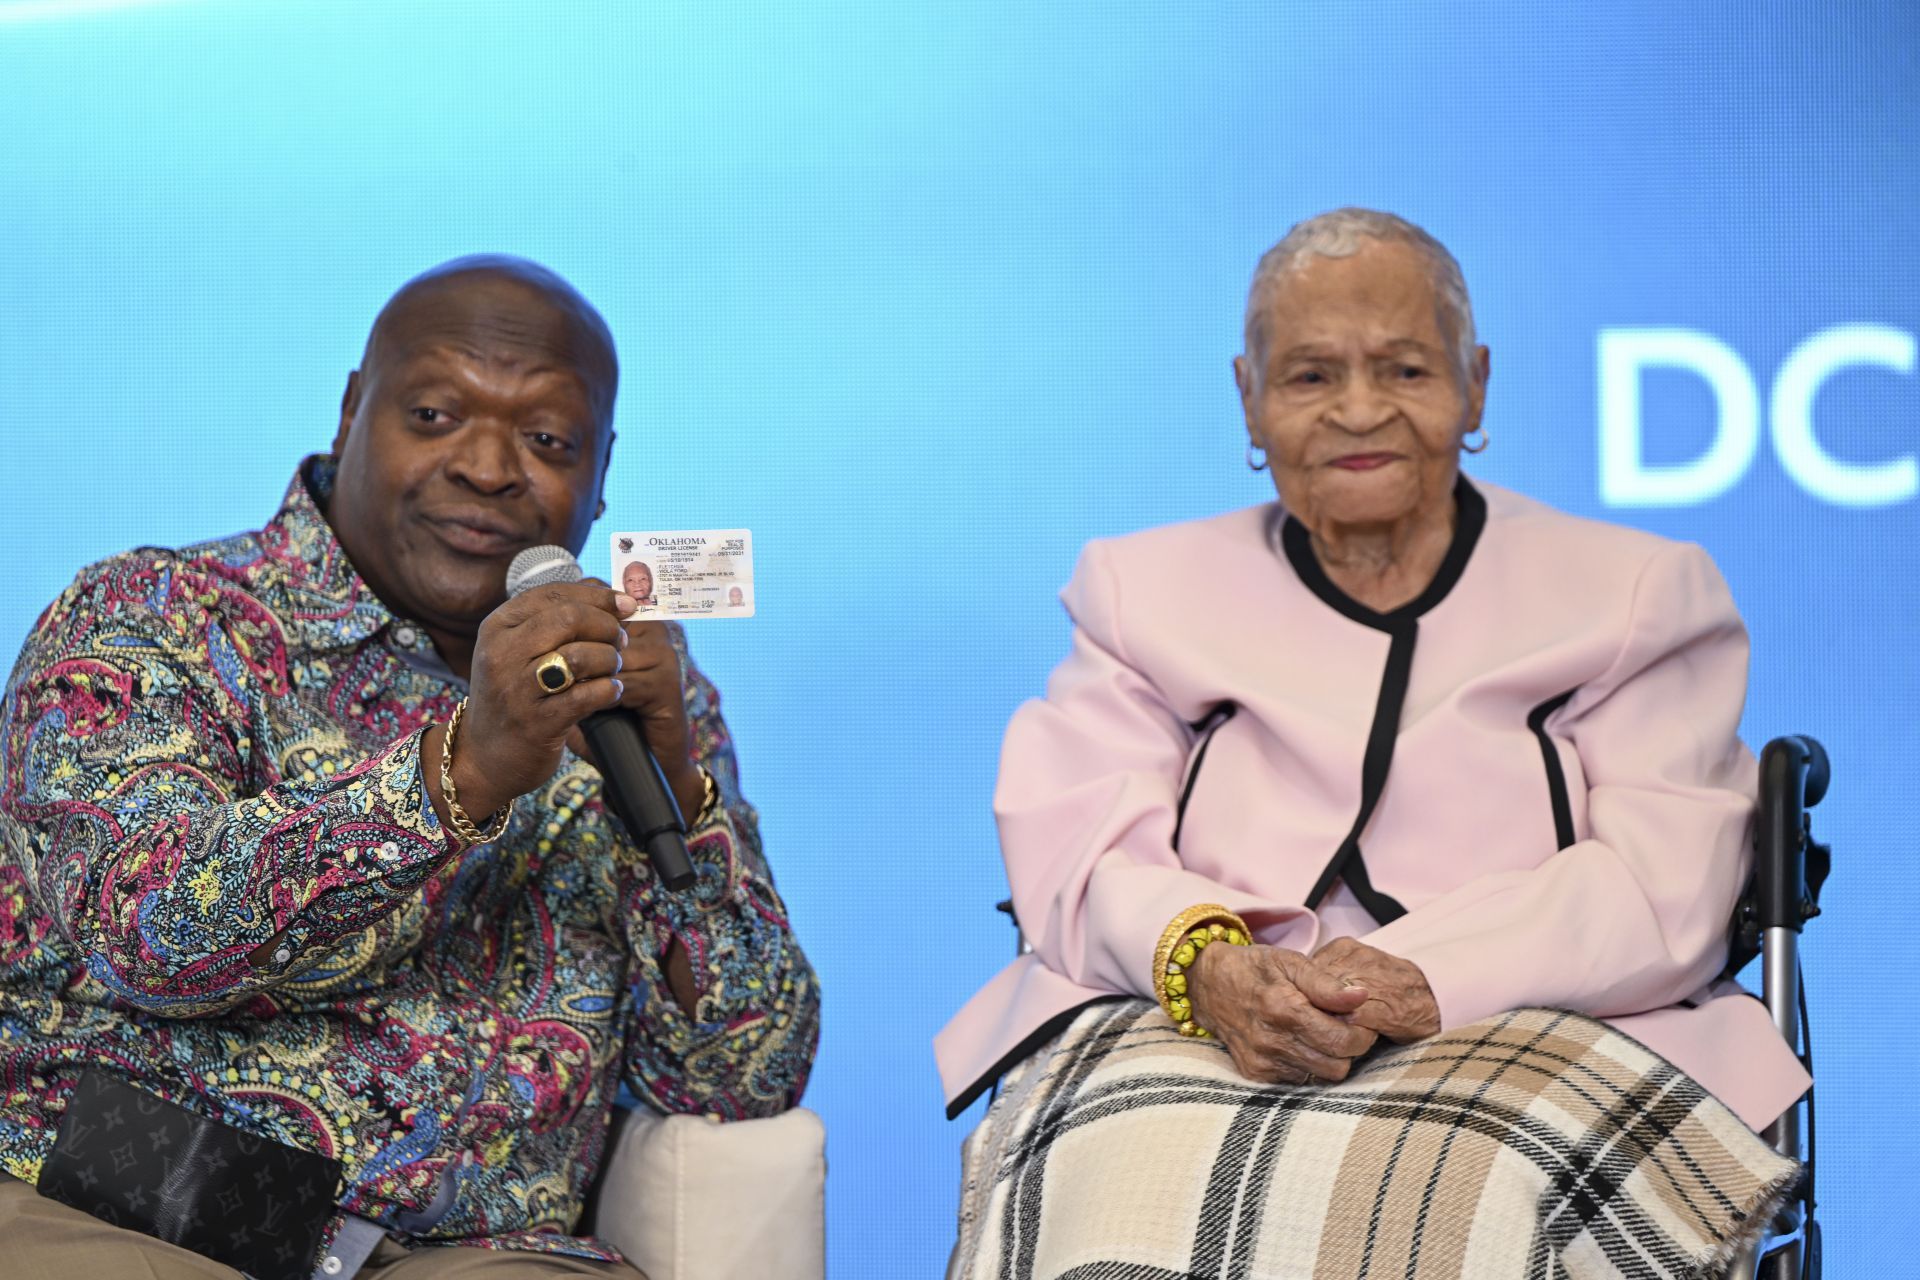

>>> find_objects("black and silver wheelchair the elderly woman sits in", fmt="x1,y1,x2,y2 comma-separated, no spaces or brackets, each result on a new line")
996,735,1834,1280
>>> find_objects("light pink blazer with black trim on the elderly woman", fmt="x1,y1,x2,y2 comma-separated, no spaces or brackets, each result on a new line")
935,480,1809,1126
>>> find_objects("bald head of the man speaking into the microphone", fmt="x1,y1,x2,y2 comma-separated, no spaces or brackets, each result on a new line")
326,257,620,656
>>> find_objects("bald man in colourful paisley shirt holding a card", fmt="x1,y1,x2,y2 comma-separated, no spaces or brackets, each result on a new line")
0,257,818,1276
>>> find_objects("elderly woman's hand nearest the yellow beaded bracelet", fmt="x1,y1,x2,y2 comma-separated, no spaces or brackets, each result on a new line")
1187,942,1375,1084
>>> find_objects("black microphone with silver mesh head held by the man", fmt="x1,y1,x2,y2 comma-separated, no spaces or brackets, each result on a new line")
507,547,693,890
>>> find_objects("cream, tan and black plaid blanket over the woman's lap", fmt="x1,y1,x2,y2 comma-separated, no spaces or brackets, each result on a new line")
947,1000,1799,1280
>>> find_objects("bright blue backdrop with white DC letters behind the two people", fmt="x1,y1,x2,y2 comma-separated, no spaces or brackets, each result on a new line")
0,0,1920,1278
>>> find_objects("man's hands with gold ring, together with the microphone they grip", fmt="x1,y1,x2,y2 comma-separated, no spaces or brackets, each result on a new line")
432,547,705,889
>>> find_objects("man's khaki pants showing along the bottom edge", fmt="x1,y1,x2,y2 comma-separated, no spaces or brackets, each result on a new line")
0,1174,647,1280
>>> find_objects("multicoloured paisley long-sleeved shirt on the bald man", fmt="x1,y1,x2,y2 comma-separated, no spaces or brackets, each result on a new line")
0,459,820,1259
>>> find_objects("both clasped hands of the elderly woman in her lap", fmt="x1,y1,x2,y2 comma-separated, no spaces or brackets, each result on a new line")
1187,938,1440,1084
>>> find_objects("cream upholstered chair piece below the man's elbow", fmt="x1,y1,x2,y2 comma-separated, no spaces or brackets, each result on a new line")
586,1107,828,1280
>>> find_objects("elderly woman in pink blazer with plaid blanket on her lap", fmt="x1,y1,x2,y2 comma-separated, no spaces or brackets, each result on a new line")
937,209,1809,1278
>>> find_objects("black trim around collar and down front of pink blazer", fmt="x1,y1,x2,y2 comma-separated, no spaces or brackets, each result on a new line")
1281,476,1489,925
